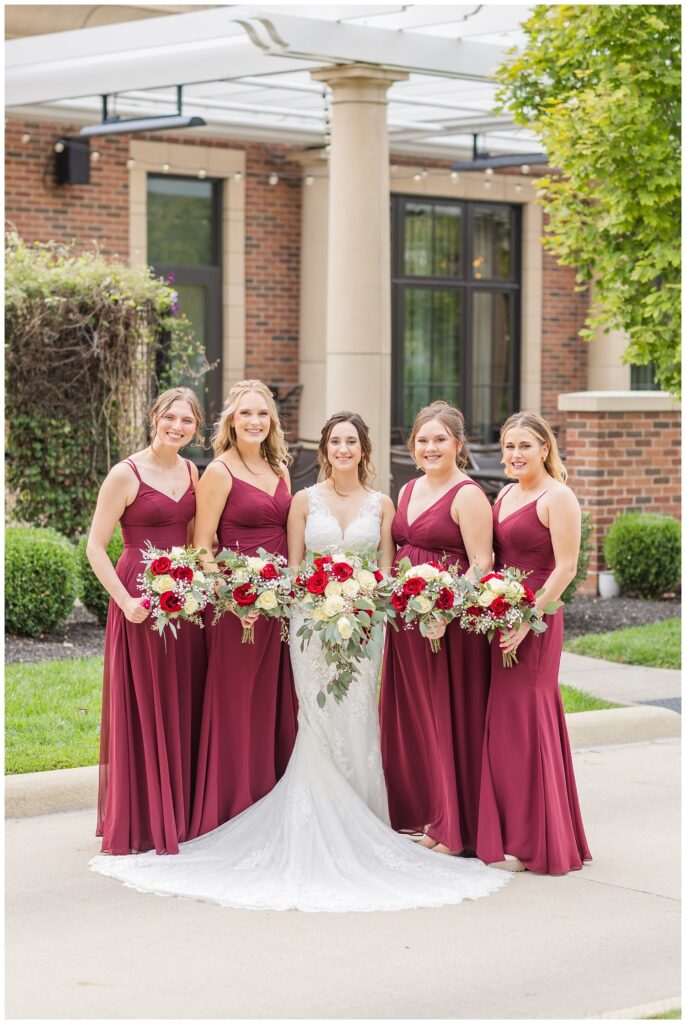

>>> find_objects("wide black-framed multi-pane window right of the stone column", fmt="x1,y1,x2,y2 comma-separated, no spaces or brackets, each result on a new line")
392,196,520,441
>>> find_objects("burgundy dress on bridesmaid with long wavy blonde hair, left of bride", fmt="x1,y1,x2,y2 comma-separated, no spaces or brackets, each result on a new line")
189,468,298,839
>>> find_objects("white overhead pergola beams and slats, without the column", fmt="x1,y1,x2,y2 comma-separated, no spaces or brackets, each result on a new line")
5,4,539,159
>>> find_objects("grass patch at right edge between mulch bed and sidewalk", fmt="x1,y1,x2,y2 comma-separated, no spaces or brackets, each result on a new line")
564,618,681,669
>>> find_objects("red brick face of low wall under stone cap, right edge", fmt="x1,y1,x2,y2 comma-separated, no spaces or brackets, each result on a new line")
565,412,681,593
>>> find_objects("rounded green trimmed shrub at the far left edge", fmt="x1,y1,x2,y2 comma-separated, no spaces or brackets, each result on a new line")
5,526,78,637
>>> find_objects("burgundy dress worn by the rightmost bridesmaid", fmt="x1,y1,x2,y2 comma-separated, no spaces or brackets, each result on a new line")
477,484,591,874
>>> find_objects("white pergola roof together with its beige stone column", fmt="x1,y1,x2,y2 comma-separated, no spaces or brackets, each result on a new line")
5,4,540,488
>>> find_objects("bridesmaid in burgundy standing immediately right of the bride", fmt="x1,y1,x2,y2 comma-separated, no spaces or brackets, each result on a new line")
381,401,492,853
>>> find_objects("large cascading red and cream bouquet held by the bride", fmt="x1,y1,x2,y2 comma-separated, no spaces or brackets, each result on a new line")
294,552,389,708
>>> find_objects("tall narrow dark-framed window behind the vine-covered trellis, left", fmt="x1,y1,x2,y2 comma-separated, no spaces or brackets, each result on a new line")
147,174,221,464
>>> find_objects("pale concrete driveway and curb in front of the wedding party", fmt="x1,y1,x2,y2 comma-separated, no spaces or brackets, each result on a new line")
6,655,681,1020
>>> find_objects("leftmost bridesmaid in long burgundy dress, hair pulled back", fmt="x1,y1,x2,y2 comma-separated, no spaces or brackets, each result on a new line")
87,387,206,854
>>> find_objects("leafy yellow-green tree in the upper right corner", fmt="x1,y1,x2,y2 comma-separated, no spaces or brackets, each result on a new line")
498,4,681,394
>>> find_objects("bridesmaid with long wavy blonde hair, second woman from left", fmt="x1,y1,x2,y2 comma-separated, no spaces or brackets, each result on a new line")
190,380,297,838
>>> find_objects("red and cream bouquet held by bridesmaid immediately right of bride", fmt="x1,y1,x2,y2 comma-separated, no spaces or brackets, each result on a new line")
391,558,471,654
